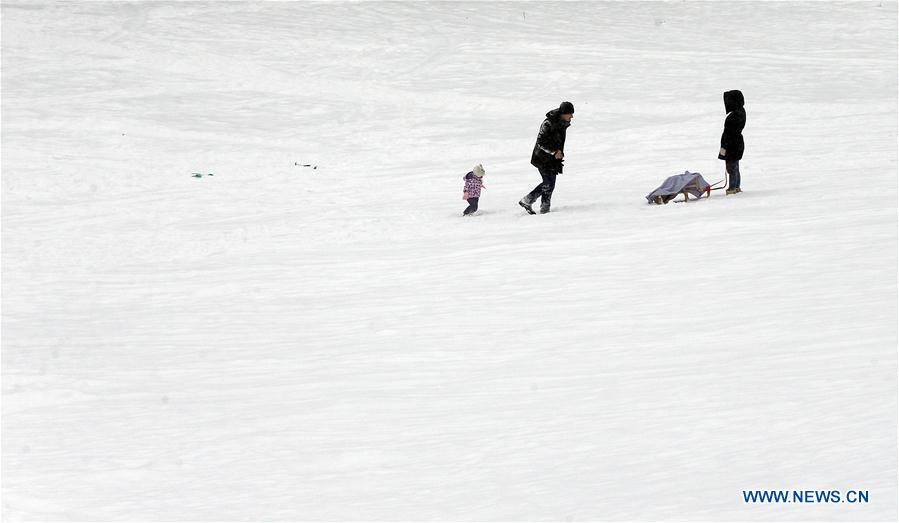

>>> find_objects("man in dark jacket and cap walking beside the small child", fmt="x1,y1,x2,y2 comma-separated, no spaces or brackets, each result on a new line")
518,102,574,214
